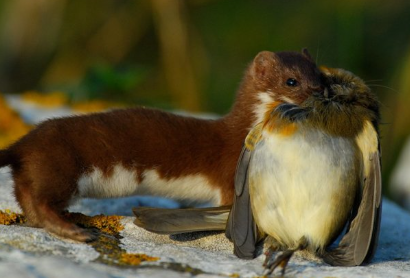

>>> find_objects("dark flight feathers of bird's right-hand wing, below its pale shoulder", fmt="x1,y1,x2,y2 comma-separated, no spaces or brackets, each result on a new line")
323,152,382,266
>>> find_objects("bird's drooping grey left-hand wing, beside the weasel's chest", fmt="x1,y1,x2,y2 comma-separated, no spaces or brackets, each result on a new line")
226,125,262,259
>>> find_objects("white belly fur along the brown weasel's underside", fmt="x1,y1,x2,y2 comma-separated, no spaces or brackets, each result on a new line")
77,164,221,205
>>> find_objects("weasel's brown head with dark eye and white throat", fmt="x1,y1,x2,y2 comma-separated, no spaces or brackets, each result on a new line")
245,50,324,125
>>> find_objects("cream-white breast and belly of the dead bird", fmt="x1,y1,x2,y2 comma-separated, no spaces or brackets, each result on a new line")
249,130,358,251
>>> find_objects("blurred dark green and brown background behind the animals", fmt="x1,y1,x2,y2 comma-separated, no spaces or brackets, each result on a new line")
0,0,410,202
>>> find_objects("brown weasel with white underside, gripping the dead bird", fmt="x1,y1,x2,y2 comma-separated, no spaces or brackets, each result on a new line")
0,51,321,242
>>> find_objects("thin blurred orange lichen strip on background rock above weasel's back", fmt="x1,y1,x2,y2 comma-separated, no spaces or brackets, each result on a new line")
21,91,68,108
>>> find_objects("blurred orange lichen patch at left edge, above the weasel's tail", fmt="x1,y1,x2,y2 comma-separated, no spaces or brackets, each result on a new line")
0,95,31,148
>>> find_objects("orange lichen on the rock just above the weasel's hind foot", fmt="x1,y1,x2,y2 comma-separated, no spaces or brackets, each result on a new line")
65,212,124,235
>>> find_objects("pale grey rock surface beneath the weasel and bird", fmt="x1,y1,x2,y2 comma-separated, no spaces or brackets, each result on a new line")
0,168,410,278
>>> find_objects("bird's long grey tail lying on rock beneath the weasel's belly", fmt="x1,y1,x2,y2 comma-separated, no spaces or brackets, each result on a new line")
133,206,231,234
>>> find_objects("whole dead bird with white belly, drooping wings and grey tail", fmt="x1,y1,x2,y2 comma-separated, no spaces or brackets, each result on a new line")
134,53,382,274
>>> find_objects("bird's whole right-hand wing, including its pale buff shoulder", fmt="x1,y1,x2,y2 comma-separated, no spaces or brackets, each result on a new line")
323,122,382,266
